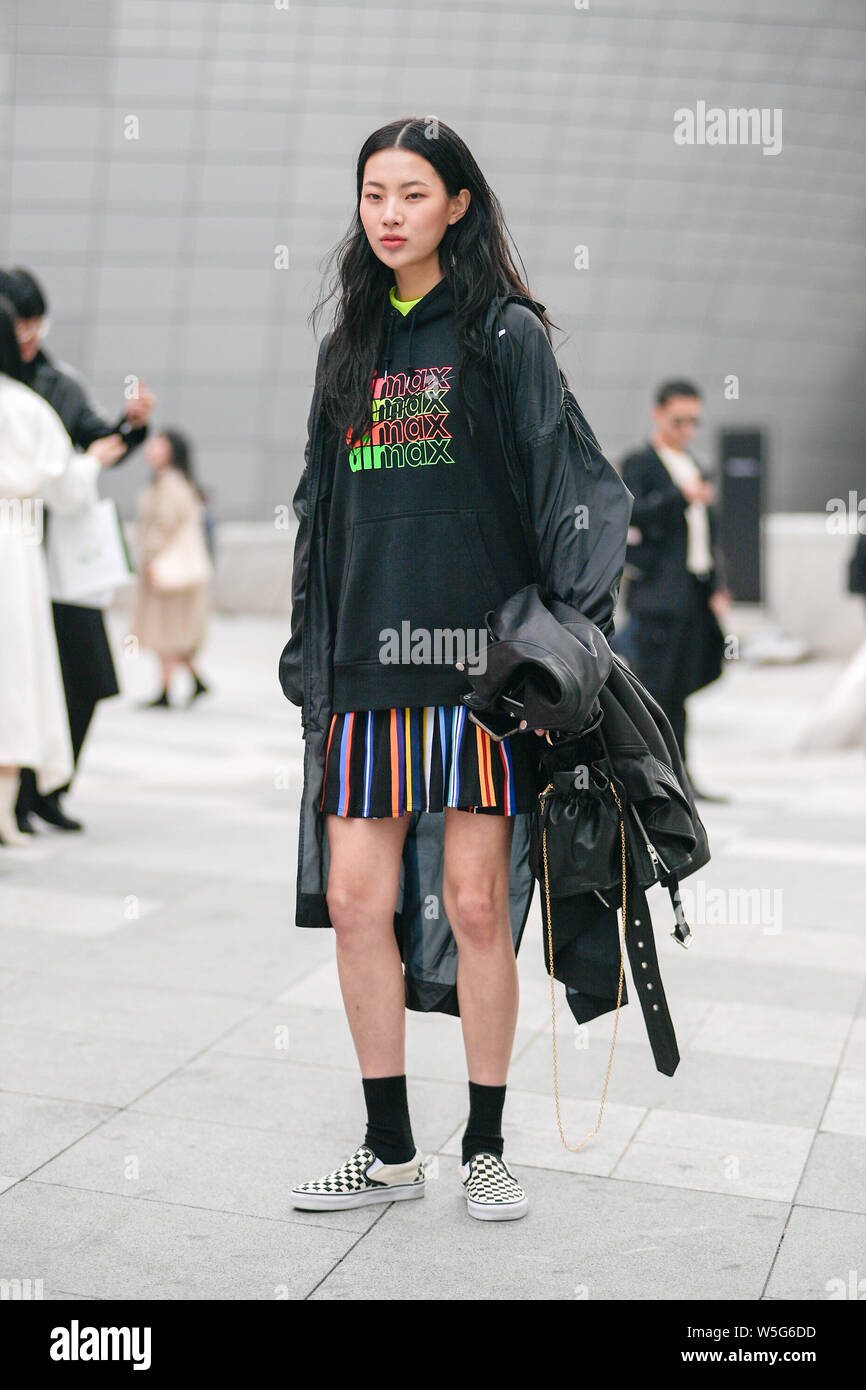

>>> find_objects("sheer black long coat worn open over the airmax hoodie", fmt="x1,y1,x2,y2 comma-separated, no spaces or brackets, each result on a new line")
279,295,632,1015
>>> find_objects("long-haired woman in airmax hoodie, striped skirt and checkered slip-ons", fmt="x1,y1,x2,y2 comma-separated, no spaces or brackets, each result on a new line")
279,118,630,1220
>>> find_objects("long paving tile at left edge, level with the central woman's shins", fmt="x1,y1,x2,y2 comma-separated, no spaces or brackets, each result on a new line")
3,972,256,1051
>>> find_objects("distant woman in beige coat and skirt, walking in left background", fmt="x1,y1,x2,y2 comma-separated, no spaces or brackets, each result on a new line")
132,430,213,709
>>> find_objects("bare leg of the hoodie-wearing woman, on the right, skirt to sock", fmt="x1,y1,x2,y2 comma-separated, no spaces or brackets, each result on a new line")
442,806,518,1086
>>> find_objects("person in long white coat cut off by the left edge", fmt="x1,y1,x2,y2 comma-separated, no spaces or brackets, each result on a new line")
0,297,125,845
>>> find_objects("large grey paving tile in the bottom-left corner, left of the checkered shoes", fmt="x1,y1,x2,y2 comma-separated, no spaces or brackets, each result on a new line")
0,1182,355,1300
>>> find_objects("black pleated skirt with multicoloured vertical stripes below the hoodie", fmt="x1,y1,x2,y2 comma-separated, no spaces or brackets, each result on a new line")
320,705,541,819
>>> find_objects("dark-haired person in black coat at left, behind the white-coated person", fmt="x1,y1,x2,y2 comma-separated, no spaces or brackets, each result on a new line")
0,267,154,831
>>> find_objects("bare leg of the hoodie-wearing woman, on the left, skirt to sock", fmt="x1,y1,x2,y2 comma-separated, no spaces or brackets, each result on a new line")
325,815,409,1077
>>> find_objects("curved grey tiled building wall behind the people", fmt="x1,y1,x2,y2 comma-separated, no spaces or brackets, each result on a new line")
0,0,866,518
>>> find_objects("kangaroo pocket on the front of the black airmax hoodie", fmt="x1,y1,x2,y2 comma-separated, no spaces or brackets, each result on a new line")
334,509,503,664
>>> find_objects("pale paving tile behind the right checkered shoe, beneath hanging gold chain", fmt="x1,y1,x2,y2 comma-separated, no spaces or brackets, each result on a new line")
441,1086,646,1176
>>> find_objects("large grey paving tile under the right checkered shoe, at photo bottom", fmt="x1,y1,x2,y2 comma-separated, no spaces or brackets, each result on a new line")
311,1159,787,1302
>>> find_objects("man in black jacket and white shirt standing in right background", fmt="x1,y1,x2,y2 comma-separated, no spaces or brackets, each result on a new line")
614,381,731,795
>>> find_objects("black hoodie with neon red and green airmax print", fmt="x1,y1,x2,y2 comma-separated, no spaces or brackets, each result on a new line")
327,278,532,713
